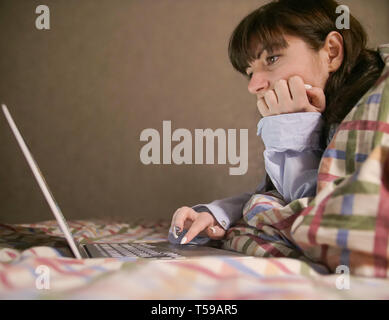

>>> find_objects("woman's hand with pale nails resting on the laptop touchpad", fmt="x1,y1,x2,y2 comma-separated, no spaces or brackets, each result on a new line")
170,207,226,244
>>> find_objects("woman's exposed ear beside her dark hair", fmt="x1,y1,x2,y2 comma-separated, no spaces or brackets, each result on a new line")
323,31,344,73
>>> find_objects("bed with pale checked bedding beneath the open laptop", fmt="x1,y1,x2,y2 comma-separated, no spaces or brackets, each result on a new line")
0,220,389,300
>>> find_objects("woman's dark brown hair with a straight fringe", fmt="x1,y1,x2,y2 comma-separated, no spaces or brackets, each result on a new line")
228,0,385,130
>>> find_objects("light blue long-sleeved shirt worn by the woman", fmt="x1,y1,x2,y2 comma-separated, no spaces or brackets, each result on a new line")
168,112,324,244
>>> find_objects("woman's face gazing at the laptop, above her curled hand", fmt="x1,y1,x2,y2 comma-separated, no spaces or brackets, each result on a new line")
246,35,329,99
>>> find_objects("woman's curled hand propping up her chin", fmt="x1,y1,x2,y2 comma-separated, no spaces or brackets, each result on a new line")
257,76,326,117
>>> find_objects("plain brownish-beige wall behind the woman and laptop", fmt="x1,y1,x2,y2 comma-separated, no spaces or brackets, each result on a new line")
0,0,389,223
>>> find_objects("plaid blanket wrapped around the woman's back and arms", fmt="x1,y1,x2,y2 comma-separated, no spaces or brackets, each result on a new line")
223,45,389,278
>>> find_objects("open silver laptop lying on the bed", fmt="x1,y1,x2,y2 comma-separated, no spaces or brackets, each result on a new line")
2,104,252,260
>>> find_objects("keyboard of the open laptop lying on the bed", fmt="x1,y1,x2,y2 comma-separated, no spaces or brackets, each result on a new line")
94,243,183,259
